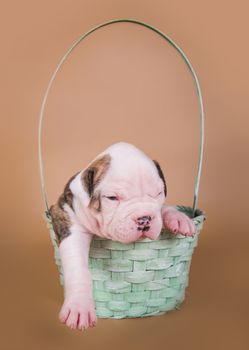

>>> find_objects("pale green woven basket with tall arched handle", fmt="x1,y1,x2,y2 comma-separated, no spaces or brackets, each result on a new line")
38,19,206,319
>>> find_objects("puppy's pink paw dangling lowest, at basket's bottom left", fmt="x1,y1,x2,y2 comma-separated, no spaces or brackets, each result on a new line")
59,294,97,331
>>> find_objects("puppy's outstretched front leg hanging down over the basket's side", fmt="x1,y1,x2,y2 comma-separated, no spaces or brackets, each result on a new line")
59,223,97,330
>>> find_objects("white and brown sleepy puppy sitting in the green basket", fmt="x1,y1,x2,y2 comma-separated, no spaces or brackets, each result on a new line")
50,142,195,330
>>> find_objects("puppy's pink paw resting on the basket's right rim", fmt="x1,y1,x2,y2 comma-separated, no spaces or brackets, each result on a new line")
162,205,196,237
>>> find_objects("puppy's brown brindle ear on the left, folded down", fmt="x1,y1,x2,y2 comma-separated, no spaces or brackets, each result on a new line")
81,154,111,198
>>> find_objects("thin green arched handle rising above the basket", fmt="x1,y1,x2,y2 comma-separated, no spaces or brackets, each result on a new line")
38,18,204,217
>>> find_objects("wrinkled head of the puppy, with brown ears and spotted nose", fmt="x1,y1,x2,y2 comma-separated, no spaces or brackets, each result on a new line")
82,142,167,243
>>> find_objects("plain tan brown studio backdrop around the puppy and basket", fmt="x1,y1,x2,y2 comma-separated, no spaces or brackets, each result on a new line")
0,0,249,350
